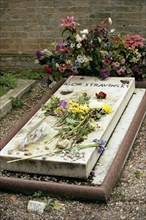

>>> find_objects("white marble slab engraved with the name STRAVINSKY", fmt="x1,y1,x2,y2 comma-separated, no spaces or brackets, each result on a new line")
0,76,135,178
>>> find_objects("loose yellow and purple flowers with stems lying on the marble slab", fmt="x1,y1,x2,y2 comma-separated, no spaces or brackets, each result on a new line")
43,92,112,154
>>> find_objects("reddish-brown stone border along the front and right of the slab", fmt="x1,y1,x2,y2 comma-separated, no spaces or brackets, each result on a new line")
0,78,146,202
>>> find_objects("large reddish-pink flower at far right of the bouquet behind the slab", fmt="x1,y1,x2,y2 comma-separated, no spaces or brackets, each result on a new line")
126,34,145,48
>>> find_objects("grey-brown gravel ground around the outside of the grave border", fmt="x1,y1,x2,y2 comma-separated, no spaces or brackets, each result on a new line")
0,82,146,220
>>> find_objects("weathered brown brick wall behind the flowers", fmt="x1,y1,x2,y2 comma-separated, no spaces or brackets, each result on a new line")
0,0,146,70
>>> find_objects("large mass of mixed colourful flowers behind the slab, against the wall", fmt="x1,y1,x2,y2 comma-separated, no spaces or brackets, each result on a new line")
36,16,146,81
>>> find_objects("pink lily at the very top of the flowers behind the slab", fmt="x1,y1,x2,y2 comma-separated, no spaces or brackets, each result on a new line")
60,16,79,30
